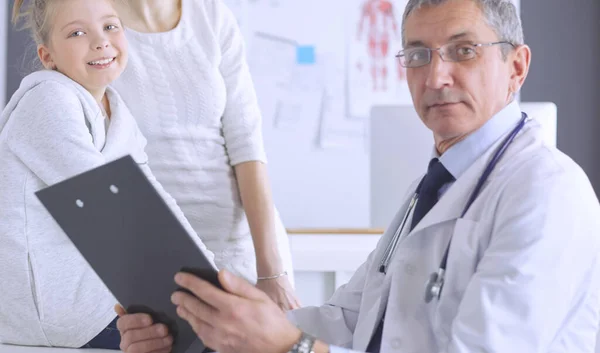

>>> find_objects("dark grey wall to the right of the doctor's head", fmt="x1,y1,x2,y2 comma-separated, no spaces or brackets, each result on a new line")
521,0,600,194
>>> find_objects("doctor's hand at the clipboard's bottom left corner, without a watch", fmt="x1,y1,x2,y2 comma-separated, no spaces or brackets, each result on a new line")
115,304,173,353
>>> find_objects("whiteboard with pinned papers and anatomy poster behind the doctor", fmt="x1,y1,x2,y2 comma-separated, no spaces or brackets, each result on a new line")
224,0,518,228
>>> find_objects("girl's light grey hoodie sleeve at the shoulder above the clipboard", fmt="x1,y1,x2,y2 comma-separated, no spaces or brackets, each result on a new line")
6,81,105,185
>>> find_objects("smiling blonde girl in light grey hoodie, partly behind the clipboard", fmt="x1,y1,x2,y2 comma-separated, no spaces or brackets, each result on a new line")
0,0,214,349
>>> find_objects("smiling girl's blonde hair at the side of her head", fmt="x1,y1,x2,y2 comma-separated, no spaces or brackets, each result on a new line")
12,0,54,45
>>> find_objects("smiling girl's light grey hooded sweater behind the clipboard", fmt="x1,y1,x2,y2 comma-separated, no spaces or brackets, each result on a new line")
0,71,212,347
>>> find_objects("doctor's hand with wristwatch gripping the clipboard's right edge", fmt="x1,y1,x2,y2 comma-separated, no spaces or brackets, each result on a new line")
171,270,301,353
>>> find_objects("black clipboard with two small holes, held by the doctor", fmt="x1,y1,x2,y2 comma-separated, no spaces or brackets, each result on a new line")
36,156,222,353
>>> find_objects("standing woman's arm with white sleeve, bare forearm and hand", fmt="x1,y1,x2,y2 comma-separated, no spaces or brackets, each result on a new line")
213,1,298,309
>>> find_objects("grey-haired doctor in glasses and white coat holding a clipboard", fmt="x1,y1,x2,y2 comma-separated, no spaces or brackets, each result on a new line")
118,0,600,353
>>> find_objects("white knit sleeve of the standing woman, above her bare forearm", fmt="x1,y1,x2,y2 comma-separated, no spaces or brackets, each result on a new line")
214,0,266,166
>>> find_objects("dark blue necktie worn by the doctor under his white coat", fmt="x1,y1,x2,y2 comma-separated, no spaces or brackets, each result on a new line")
367,158,454,353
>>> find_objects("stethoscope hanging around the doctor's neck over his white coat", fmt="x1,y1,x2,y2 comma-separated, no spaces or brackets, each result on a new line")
379,113,528,303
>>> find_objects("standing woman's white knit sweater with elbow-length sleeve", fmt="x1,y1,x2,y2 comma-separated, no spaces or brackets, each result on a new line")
113,0,291,281
